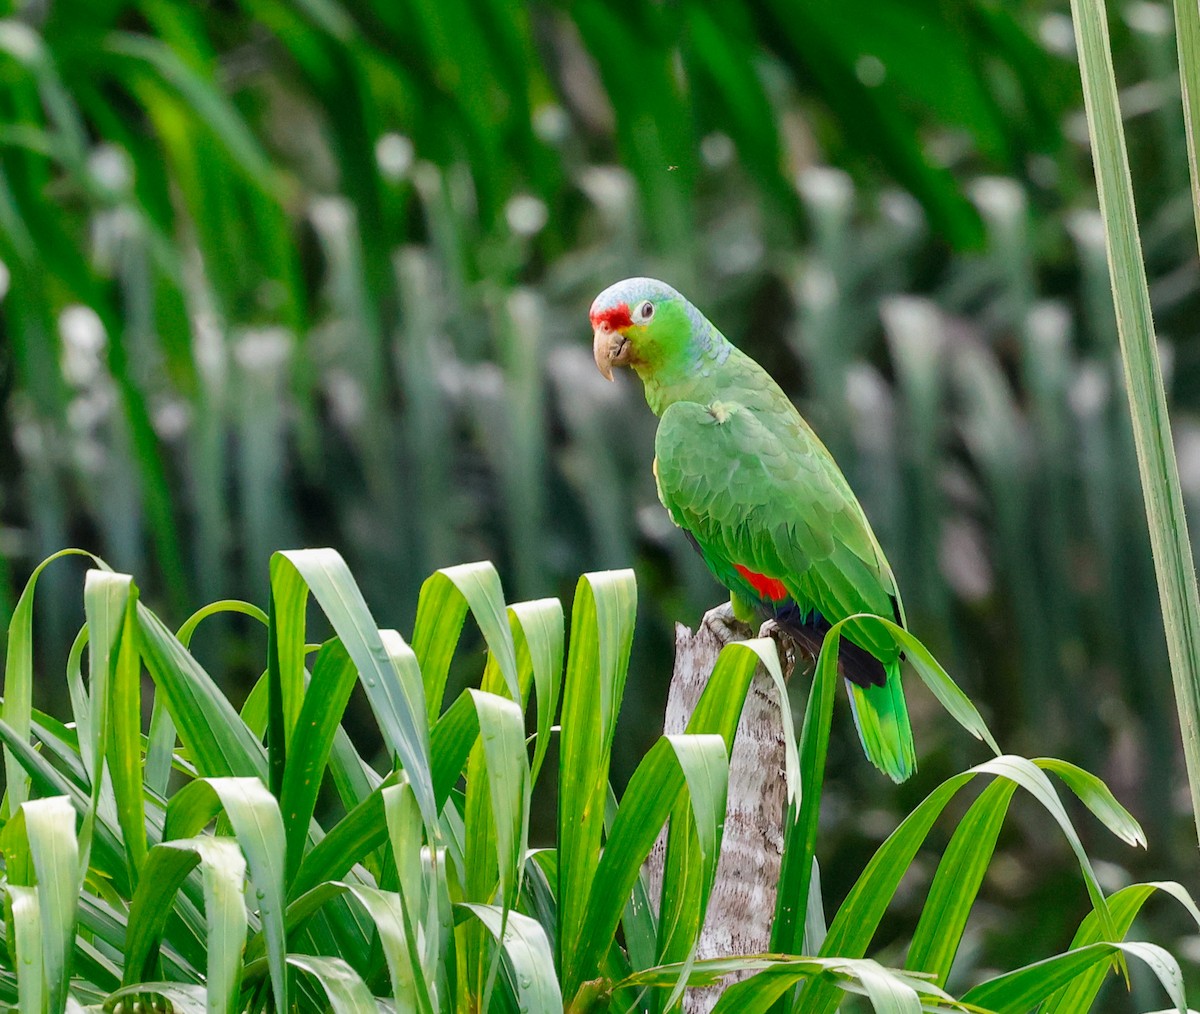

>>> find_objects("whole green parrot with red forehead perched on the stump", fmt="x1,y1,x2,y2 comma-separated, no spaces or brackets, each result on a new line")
589,278,917,782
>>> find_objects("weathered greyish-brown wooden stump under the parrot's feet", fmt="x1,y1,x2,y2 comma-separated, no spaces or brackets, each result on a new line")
646,604,787,1014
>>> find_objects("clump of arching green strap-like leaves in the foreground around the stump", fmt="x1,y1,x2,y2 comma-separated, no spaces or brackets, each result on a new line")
0,550,1200,1012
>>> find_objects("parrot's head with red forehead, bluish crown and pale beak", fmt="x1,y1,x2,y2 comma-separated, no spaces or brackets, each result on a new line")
588,278,700,380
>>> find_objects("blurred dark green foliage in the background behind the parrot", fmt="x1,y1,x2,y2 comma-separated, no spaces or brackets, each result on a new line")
0,0,1200,1009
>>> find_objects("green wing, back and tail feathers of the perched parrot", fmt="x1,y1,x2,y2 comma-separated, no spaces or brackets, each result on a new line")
654,391,916,781
